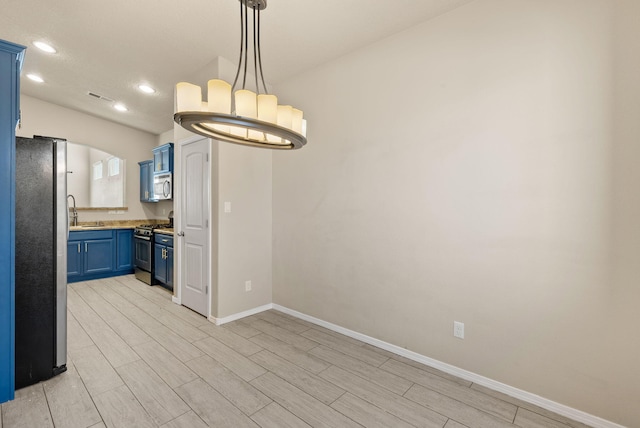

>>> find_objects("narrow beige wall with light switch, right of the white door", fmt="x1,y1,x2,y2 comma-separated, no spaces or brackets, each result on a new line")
174,58,272,321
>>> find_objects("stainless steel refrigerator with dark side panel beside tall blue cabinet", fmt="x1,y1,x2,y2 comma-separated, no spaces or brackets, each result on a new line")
15,137,69,389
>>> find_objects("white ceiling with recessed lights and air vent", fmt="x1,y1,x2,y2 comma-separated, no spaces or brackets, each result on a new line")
0,0,472,134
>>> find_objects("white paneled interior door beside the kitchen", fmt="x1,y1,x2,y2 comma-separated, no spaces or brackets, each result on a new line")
180,139,210,316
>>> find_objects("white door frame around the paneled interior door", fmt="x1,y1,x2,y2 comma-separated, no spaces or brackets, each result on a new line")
172,135,216,319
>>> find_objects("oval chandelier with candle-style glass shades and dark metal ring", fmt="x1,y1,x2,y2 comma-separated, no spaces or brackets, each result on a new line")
173,0,307,150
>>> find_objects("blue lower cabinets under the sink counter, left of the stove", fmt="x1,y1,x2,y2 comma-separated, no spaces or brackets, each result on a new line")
67,229,133,282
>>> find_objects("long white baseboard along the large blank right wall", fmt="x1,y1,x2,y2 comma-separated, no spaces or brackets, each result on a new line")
272,303,625,428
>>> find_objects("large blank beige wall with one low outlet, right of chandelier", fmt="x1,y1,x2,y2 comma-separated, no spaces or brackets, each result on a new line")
273,0,640,426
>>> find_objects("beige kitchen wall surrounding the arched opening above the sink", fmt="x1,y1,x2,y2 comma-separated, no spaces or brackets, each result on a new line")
16,95,170,222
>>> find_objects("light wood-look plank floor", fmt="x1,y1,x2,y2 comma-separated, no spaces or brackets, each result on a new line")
0,275,585,428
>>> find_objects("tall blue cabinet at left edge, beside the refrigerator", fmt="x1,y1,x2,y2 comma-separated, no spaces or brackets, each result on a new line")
0,40,25,403
